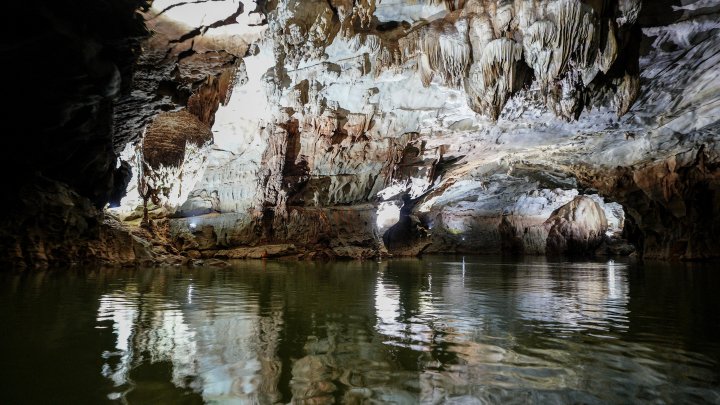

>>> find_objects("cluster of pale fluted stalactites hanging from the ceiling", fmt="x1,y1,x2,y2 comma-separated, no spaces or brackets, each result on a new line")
275,0,641,122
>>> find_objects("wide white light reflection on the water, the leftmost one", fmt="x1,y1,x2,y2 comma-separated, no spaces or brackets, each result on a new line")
97,284,282,402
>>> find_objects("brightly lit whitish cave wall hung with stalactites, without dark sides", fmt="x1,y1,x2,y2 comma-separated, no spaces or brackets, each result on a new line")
143,1,718,258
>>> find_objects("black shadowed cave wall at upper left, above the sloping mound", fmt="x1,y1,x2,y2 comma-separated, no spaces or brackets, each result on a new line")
2,0,148,206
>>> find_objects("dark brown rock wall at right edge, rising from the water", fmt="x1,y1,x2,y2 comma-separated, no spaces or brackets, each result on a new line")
576,146,720,260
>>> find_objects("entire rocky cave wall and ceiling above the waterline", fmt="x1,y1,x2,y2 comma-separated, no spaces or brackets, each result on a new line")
1,0,720,264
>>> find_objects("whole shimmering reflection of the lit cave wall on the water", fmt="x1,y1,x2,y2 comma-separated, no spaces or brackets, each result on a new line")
83,257,716,403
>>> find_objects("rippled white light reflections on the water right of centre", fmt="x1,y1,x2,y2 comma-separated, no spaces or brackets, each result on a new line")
375,257,636,403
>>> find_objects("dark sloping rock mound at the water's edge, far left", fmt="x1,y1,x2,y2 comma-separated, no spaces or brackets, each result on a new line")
0,177,162,268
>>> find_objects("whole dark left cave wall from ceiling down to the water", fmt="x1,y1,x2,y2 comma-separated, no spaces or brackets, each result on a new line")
0,0,149,266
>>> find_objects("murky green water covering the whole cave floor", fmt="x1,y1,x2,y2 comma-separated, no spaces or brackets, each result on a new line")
0,257,720,404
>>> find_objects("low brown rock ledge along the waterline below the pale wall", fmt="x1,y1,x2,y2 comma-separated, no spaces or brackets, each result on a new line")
170,204,382,259
